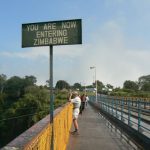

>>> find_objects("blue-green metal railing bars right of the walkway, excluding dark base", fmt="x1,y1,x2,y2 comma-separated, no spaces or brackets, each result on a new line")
90,95,150,138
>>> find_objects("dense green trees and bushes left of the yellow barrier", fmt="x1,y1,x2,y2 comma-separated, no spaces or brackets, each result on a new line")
0,76,68,146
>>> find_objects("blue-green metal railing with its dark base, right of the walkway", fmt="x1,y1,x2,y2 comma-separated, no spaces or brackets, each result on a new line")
89,95,150,149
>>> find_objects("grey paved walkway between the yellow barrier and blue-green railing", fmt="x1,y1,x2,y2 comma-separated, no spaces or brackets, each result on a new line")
67,106,137,150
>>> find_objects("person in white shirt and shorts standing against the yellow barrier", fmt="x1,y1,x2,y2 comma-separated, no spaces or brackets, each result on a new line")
69,91,81,134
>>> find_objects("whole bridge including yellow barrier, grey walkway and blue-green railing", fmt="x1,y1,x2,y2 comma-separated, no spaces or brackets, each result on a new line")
2,95,150,150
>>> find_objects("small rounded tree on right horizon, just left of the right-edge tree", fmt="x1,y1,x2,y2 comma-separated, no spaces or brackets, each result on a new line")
123,80,138,90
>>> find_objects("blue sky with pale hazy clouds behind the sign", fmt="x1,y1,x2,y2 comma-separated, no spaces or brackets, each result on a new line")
0,0,150,87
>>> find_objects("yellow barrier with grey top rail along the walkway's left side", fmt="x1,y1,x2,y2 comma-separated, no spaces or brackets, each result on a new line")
1,103,72,150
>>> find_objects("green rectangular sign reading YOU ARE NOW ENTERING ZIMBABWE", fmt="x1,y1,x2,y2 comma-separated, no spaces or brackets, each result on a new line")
22,19,82,47
